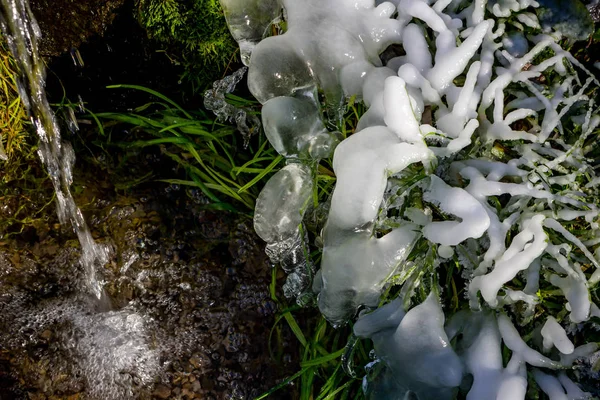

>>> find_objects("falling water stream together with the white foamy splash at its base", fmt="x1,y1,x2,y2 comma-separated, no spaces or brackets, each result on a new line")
0,0,164,399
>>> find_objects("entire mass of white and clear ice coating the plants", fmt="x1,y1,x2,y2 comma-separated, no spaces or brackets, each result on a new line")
224,0,600,400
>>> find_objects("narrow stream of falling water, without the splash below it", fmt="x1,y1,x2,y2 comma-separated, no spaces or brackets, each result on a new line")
0,0,108,299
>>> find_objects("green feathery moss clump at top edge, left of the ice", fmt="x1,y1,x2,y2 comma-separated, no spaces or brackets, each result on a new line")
138,0,237,90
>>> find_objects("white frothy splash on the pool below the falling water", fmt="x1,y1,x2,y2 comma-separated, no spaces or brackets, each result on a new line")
0,288,161,400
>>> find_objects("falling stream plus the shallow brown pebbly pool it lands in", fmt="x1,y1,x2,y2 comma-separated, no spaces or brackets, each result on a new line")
0,4,295,400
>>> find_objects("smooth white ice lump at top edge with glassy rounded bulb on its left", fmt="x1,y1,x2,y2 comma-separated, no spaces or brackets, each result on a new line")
249,0,402,111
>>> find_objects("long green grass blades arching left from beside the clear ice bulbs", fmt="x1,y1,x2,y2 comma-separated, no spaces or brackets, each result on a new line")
90,85,283,214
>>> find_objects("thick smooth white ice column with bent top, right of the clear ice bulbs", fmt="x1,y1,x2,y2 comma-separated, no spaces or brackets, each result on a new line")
314,126,431,325
